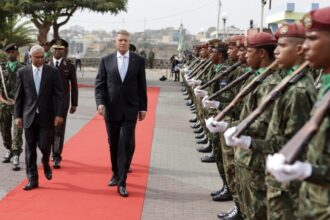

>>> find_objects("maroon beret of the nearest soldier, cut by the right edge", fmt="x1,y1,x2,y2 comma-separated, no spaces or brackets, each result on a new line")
302,7,330,31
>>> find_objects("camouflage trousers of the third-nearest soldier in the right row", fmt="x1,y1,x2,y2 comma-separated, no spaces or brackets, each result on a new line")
235,164,267,220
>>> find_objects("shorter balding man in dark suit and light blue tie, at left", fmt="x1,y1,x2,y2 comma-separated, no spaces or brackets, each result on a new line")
14,45,64,190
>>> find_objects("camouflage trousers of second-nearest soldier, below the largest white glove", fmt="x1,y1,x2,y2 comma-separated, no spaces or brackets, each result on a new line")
267,185,299,220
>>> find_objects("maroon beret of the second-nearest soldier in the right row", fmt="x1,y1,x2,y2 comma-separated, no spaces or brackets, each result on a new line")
275,23,306,39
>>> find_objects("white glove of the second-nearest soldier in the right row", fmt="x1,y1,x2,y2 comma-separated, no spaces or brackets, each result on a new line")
224,127,252,150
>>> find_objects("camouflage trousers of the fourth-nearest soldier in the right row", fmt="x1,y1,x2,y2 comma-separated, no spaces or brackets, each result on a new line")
220,134,238,198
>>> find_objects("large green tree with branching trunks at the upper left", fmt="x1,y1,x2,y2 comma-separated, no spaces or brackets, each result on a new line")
2,0,127,43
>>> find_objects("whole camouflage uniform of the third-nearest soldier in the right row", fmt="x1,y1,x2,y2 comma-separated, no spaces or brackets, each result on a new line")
235,68,281,220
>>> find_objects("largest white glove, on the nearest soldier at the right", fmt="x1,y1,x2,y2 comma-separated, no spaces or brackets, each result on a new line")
267,154,312,182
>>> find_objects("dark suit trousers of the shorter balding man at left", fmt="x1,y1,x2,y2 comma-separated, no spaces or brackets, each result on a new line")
24,113,54,181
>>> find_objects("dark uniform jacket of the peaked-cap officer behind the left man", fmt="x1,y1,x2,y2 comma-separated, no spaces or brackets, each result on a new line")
49,58,78,109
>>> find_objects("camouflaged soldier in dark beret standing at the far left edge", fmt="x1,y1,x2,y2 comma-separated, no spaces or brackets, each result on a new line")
0,43,24,171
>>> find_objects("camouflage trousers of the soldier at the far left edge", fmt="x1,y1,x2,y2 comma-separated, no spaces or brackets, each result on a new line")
0,108,23,156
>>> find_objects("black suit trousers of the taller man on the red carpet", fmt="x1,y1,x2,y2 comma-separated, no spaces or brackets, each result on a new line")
106,120,136,186
